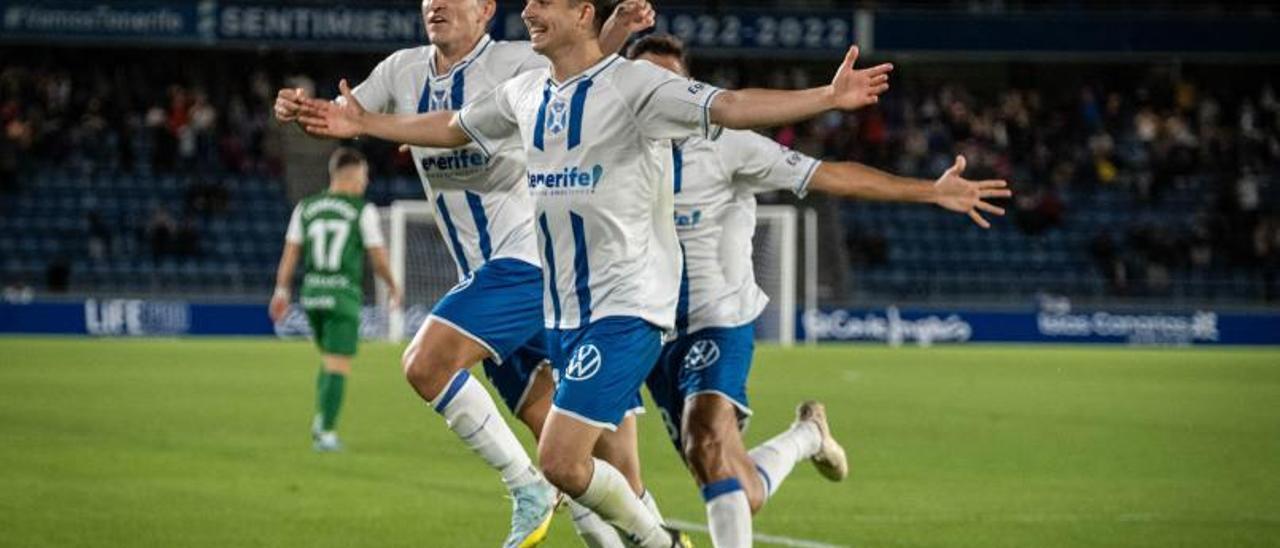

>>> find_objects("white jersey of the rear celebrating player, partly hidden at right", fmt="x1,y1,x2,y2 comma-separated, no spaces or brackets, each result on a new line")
672,131,819,333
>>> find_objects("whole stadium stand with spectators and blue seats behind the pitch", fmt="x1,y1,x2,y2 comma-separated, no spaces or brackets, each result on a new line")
0,46,1280,302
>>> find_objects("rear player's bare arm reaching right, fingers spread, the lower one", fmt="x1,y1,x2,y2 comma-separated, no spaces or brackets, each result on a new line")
809,156,1012,228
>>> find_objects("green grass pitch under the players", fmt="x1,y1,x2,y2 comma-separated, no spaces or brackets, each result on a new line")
0,338,1280,548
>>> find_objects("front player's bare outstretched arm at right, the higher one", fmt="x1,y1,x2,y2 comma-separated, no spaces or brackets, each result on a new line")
710,46,893,129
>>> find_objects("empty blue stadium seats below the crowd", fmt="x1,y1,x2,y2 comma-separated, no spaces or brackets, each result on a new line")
0,162,1265,301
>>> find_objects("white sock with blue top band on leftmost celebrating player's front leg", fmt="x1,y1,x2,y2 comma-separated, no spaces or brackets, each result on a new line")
431,370,541,489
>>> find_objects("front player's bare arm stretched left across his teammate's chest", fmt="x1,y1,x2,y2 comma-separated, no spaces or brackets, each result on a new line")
298,79,471,149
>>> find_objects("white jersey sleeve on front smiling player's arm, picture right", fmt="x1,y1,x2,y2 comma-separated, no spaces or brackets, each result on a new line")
620,61,722,140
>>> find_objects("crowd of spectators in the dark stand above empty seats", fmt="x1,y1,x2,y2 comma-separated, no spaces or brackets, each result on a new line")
0,47,1280,302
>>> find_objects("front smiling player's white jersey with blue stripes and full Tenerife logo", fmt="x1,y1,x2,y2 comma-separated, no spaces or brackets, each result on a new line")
458,55,719,329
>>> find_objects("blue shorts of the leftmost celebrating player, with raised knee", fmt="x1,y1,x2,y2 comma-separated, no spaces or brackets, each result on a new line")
430,259,547,412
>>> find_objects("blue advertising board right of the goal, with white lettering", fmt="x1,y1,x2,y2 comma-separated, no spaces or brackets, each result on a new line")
796,307,1280,346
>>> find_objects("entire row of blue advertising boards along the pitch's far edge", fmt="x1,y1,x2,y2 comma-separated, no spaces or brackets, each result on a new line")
0,298,1280,346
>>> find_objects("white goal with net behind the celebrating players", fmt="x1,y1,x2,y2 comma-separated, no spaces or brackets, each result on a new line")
378,200,799,346
